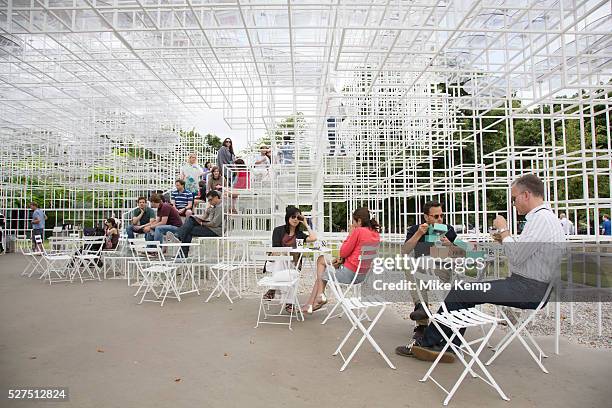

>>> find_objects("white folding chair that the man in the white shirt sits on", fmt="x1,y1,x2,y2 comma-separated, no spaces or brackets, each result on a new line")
486,282,554,374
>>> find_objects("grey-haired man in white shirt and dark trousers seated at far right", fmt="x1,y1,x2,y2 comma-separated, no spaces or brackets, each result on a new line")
395,174,566,363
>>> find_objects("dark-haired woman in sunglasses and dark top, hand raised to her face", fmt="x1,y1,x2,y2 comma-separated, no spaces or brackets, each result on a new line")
264,206,317,308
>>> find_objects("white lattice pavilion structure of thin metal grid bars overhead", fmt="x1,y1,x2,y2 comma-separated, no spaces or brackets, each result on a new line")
0,0,612,239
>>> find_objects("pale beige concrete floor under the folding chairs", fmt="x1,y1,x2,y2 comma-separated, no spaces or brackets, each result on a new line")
0,254,612,408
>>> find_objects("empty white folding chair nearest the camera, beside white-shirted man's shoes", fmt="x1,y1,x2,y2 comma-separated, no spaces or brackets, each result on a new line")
414,272,510,405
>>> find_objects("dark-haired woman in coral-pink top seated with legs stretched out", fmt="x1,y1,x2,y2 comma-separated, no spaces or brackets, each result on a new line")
302,207,380,313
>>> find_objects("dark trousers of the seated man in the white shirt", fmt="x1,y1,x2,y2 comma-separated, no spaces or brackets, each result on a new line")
420,274,548,347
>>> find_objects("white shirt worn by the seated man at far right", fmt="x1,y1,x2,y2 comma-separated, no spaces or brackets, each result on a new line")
502,204,567,282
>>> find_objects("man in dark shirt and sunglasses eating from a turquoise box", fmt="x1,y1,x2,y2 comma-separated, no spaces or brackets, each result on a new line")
402,201,457,344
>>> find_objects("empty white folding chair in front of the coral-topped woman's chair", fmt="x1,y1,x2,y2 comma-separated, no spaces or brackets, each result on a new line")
327,268,395,371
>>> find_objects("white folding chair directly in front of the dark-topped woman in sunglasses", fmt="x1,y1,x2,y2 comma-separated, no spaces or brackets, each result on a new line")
253,247,304,330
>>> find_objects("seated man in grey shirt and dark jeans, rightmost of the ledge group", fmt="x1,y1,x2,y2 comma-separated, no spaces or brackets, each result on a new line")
166,190,223,258
